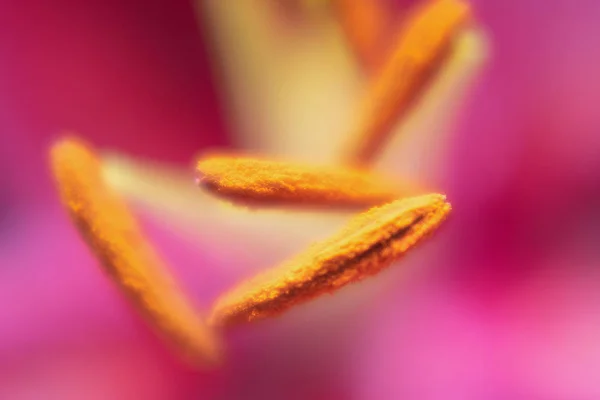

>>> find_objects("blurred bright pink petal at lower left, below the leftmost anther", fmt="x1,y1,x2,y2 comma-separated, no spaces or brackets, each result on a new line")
0,206,225,399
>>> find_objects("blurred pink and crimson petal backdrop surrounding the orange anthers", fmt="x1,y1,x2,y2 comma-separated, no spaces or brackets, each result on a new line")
0,0,600,399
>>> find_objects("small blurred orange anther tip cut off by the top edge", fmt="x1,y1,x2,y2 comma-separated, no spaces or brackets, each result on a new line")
333,0,390,69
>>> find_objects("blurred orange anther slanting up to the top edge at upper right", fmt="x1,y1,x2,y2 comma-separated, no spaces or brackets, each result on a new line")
344,0,471,165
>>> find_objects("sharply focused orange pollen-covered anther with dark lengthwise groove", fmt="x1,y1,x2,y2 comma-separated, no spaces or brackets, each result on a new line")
210,194,451,325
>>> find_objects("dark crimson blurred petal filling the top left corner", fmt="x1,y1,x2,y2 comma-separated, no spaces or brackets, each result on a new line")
0,1,227,205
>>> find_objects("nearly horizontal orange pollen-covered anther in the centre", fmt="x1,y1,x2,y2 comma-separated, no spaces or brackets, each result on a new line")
197,156,418,207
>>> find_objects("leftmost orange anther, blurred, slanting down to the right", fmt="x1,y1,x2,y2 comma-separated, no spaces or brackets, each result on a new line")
51,139,221,365
